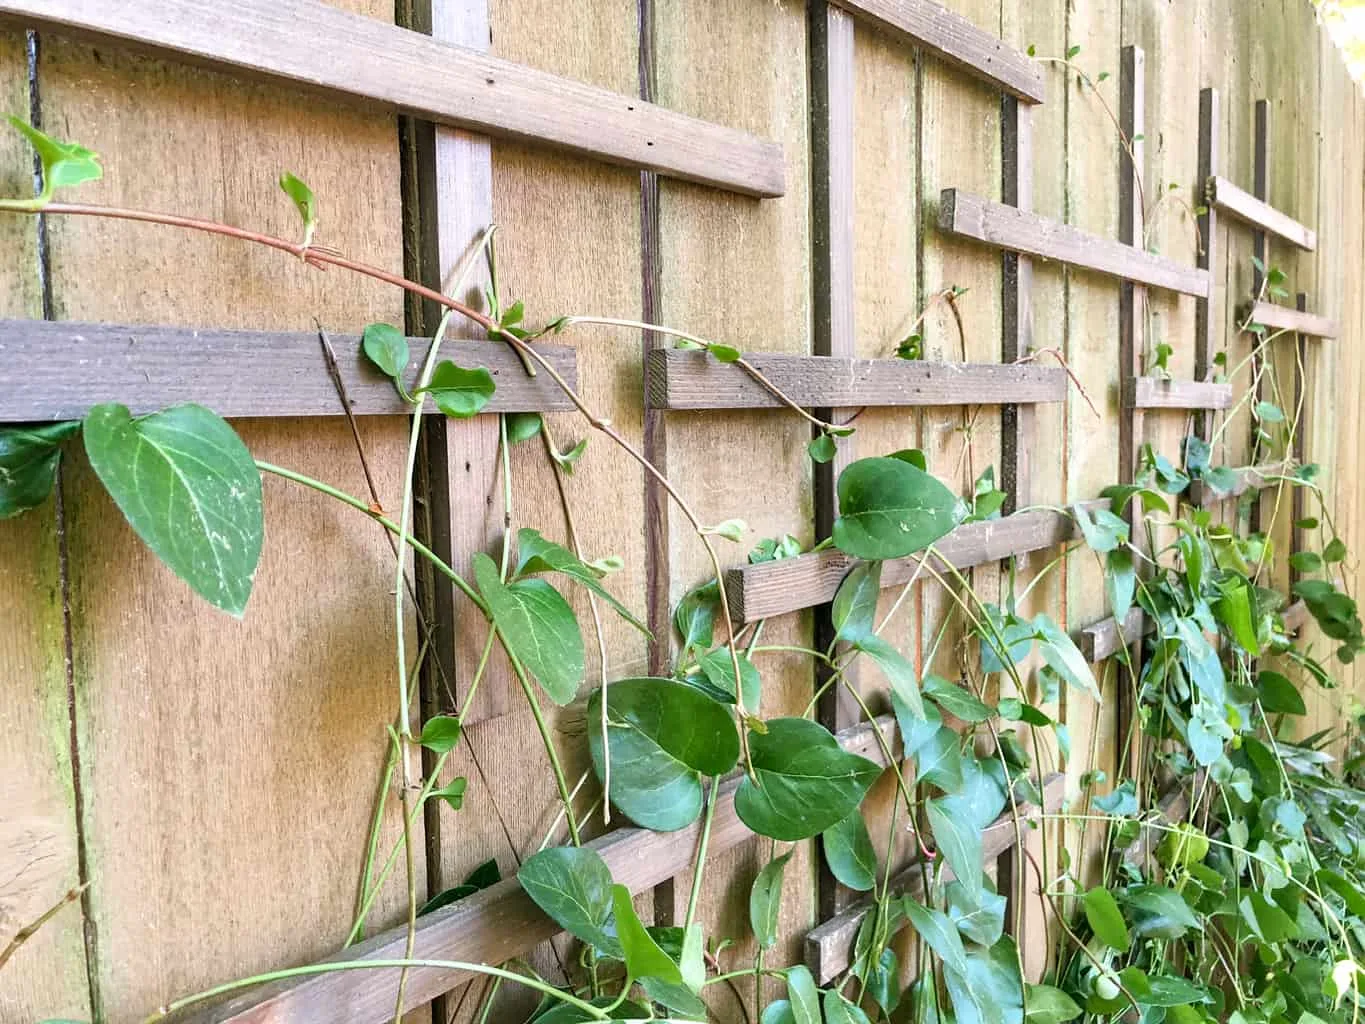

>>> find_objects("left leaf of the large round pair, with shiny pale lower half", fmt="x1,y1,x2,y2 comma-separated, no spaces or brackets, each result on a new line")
587,679,740,831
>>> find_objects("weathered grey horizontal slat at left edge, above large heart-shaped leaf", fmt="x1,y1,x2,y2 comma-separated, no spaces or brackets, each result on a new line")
0,319,577,423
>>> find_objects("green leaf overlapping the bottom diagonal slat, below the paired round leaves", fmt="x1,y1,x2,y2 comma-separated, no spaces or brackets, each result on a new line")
516,847,622,958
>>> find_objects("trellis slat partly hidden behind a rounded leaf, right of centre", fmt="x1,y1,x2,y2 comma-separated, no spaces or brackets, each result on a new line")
725,498,1110,623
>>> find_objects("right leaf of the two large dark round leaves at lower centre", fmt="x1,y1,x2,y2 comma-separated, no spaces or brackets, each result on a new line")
734,718,882,842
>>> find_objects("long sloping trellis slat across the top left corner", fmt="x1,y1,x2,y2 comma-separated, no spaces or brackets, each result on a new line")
0,0,785,197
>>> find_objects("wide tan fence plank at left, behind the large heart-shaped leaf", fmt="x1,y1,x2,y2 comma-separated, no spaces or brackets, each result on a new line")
37,0,423,1024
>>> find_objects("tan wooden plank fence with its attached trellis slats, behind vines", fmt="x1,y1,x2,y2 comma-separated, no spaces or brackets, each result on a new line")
0,0,1365,1024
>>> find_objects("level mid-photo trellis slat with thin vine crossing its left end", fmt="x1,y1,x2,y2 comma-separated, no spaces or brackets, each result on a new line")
646,348,1066,410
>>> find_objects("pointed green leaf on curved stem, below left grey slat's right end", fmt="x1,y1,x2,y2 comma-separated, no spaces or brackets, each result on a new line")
474,552,584,706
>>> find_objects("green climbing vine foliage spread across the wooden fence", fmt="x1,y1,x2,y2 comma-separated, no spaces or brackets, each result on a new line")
8,106,1365,1024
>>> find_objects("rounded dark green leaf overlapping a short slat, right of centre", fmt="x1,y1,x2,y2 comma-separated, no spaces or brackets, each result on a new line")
833,459,965,561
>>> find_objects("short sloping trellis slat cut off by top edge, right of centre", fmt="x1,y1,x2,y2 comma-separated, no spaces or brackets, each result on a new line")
834,0,1046,104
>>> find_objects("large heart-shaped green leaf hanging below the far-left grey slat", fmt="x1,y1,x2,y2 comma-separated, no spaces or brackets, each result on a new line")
85,404,265,618
